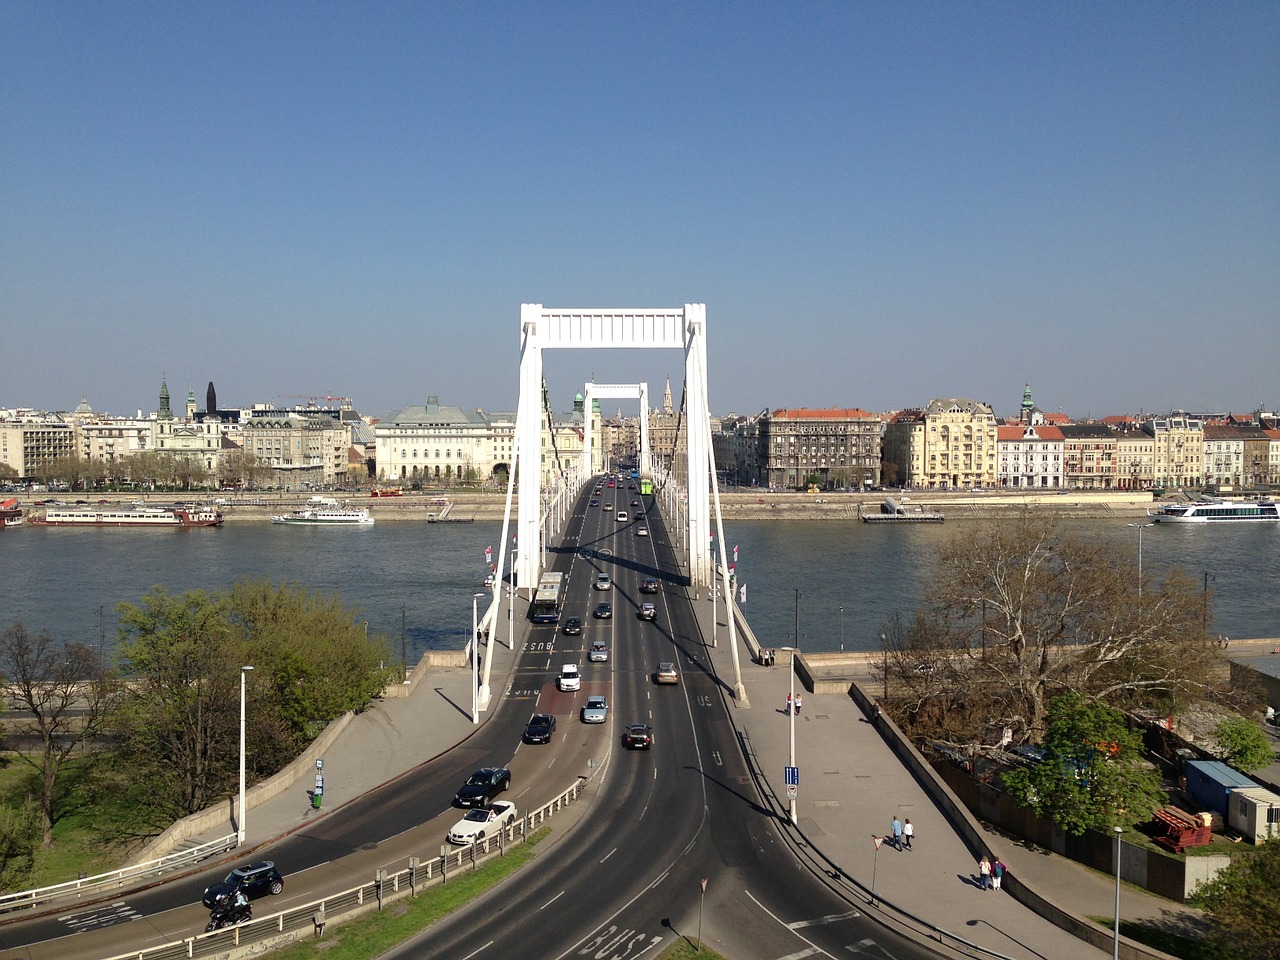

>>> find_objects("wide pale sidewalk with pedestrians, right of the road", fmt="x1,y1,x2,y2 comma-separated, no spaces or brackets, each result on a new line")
694,599,1199,960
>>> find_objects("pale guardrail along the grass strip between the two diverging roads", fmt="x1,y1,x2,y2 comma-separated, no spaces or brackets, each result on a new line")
97,777,591,960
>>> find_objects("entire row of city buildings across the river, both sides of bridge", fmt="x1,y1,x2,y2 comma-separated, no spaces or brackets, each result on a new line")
0,381,1280,490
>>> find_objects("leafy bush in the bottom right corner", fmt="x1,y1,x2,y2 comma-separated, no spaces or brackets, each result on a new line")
1193,840,1280,960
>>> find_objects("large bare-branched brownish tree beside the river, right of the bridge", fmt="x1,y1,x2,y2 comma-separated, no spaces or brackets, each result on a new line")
886,512,1222,742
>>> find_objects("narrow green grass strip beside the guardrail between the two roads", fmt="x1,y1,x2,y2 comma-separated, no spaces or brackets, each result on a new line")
264,827,550,960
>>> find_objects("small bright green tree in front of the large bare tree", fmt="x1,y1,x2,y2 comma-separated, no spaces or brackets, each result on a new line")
1004,692,1165,836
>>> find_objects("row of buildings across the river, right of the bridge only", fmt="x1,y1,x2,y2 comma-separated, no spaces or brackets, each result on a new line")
716,387,1280,492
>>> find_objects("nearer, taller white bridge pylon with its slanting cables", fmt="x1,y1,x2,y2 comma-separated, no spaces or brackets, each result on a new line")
480,303,746,708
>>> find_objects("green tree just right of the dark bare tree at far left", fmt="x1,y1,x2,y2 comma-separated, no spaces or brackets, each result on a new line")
118,586,244,818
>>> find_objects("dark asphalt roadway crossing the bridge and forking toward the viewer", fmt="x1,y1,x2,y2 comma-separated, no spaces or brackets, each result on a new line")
0,478,1105,960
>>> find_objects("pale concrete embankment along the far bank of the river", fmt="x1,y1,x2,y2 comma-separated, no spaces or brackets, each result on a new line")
202,490,1152,522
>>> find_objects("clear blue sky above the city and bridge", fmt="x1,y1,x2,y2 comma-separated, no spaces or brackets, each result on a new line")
0,0,1280,416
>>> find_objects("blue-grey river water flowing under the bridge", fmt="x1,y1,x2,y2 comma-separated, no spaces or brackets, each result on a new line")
0,520,1280,662
